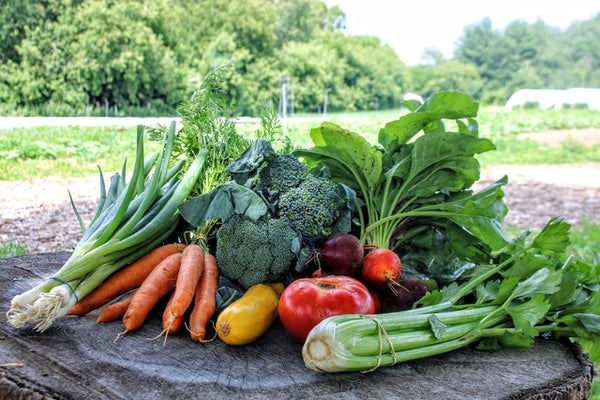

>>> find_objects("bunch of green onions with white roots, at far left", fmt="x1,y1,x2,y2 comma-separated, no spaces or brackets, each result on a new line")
7,122,206,332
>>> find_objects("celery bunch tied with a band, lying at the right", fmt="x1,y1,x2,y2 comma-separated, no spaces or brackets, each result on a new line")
302,219,600,372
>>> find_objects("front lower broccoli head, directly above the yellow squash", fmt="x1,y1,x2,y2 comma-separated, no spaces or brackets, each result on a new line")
215,215,300,289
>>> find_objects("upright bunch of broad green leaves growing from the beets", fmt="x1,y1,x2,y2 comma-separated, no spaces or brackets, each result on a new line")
295,92,507,282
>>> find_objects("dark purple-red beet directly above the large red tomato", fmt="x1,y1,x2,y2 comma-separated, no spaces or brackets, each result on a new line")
311,232,364,278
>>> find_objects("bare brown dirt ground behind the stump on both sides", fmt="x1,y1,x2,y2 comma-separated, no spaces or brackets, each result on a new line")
0,129,600,253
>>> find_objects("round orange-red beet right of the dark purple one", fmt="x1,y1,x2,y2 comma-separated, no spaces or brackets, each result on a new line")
362,247,402,292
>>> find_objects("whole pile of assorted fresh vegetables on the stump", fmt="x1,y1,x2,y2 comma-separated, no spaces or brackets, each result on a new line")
8,84,600,372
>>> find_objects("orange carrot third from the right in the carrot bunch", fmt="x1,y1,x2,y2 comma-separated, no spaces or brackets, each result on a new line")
120,253,182,335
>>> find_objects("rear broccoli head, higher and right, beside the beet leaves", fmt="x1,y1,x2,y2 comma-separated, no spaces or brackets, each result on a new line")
277,175,350,241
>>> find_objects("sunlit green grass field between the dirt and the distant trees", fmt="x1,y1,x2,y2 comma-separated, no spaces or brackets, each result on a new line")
0,108,600,180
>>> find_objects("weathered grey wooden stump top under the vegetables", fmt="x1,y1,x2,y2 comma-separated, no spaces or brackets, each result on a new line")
0,253,593,400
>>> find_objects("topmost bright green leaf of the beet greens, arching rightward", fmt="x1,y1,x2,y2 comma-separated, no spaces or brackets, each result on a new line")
379,92,479,151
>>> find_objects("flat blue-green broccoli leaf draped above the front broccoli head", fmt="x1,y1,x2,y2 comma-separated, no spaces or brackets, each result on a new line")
179,182,268,227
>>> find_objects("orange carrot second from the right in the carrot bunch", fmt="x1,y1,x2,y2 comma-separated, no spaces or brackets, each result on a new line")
163,244,204,334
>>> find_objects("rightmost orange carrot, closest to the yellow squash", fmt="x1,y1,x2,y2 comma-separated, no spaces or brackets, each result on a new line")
189,253,219,342
